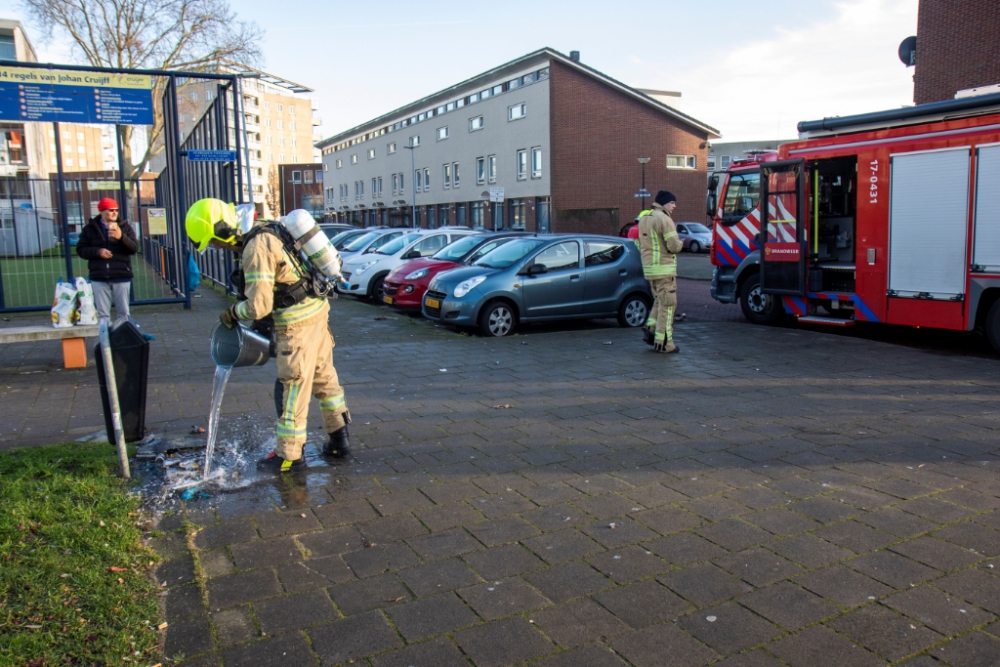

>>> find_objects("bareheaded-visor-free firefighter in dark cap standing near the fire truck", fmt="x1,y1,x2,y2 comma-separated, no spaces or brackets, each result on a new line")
639,190,684,354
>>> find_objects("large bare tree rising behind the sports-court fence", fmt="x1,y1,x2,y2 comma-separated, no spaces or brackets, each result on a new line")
21,0,264,178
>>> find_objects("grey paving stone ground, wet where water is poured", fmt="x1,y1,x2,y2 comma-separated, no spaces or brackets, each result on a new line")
0,281,1000,667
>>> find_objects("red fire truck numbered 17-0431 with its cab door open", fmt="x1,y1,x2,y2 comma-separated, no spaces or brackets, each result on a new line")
708,94,1000,351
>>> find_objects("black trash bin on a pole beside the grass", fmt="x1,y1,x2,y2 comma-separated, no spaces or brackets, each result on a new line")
94,320,149,442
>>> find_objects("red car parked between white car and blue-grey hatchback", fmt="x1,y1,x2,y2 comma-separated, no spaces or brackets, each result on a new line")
384,232,525,312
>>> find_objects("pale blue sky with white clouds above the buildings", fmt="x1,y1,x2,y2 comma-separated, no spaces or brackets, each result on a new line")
0,0,918,141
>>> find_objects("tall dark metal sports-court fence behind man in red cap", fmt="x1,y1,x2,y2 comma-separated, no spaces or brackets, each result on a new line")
0,60,245,312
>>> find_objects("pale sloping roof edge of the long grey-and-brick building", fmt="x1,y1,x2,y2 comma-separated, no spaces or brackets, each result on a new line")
313,46,722,149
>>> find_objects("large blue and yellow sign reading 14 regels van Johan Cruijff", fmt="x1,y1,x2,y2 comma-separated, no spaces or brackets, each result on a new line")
0,67,153,125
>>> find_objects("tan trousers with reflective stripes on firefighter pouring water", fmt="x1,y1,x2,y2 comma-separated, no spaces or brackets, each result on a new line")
274,315,347,460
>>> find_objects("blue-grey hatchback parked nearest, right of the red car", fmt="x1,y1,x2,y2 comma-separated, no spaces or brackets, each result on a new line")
422,234,653,336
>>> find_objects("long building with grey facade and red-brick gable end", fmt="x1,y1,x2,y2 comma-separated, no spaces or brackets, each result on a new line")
317,48,719,234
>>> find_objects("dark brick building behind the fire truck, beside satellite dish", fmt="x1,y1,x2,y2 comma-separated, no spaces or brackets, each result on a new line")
913,0,1000,104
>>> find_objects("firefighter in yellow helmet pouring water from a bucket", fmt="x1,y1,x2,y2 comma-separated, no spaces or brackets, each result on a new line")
185,199,350,472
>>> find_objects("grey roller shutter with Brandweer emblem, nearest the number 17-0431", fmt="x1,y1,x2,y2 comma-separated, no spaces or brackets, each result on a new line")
889,151,969,299
